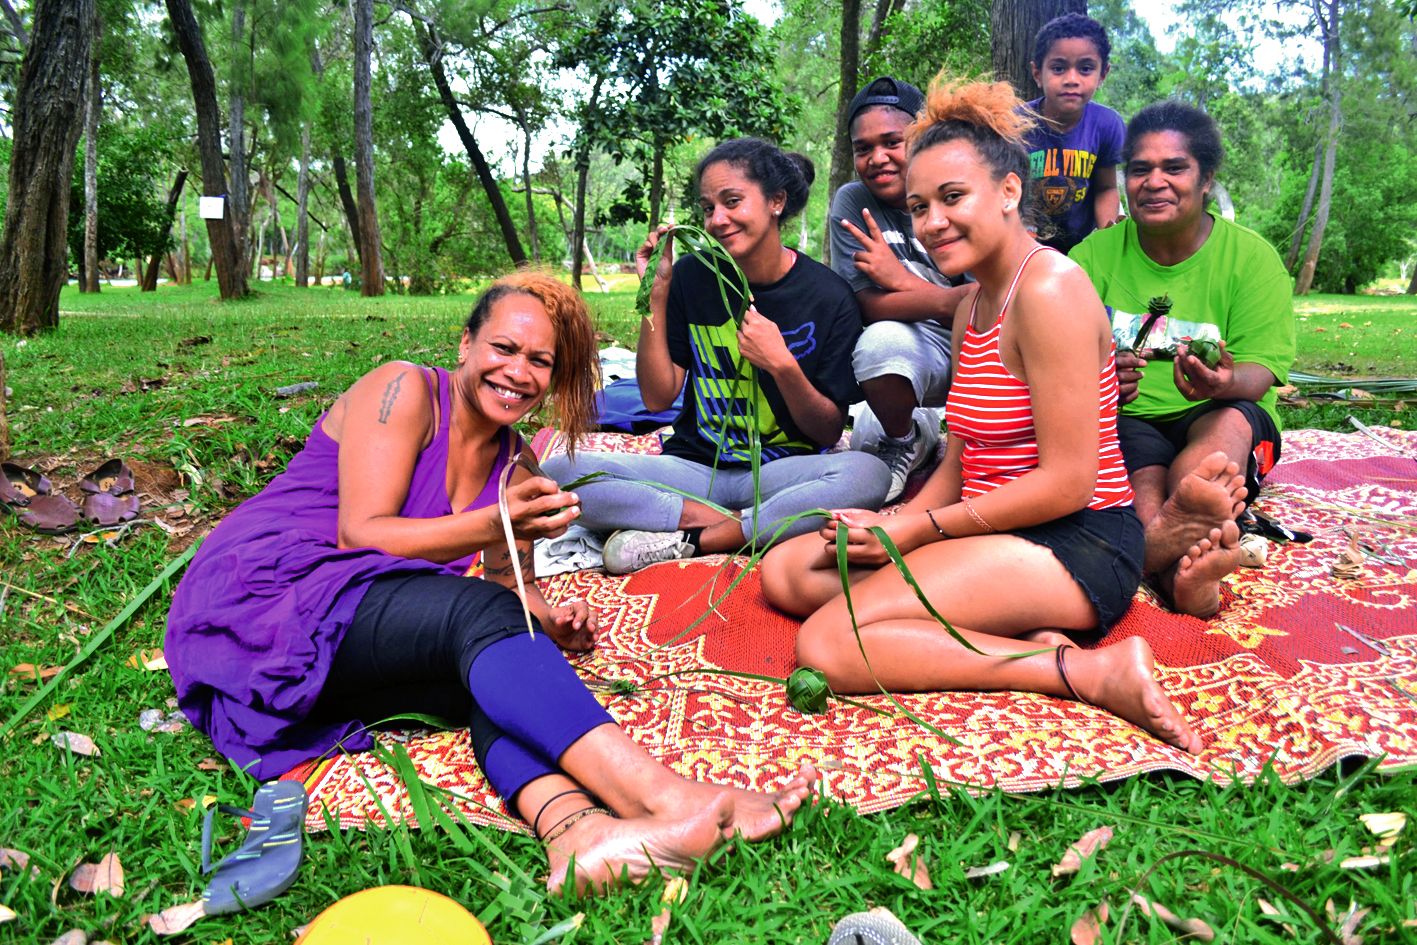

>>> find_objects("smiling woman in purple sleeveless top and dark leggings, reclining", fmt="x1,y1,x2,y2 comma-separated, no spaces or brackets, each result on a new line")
166,273,816,890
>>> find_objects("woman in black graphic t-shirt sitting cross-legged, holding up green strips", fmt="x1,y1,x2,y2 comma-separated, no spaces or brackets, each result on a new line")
547,137,890,574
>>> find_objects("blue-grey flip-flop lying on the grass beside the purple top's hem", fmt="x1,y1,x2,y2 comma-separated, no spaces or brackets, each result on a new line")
201,781,310,915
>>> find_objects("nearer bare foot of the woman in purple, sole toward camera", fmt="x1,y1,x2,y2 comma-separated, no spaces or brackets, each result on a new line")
546,793,733,893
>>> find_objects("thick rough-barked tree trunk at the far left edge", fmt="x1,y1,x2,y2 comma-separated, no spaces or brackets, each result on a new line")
0,0,98,334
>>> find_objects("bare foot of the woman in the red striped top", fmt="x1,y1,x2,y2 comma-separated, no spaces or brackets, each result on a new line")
1066,636,1204,755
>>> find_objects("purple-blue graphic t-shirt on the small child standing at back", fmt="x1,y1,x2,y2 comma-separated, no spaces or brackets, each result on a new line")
1026,99,1127,252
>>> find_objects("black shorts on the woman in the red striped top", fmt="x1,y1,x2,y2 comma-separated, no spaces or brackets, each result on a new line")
1009,506,1146,630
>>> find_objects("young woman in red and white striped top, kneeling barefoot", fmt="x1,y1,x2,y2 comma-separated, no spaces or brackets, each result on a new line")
762,75,1202,752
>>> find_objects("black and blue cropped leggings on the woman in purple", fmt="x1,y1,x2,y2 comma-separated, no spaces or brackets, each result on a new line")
315,572,614,806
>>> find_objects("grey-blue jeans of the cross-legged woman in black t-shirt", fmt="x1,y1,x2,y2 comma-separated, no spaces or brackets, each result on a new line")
543,452,890,544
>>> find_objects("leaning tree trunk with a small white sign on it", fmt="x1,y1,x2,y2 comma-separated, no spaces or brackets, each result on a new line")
166,0,248,299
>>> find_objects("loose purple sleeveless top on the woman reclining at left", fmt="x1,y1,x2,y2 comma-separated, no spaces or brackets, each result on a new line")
164,367,520,779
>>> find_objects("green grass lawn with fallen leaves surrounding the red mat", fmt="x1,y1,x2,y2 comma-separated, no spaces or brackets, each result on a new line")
0,285,1417,945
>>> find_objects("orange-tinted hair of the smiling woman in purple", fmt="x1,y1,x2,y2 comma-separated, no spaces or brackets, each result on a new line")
463,269,601,453
